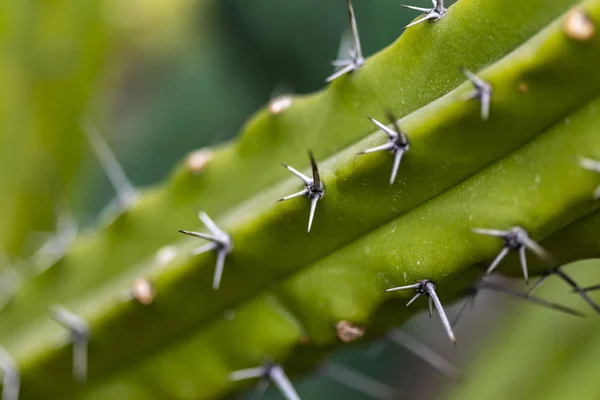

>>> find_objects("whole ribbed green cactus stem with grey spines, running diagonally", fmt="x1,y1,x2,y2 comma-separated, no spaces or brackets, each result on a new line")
0,0,600,399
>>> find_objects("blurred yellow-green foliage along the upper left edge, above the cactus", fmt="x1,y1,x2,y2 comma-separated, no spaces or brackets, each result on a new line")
0,0,110,258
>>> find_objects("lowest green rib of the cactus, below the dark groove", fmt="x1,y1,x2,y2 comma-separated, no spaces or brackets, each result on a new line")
88,91,600,398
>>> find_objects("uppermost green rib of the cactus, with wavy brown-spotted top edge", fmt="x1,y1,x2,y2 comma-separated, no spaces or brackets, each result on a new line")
0,0,574,330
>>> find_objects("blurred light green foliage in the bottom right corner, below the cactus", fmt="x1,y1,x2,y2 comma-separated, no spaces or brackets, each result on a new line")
439,260,600,400
